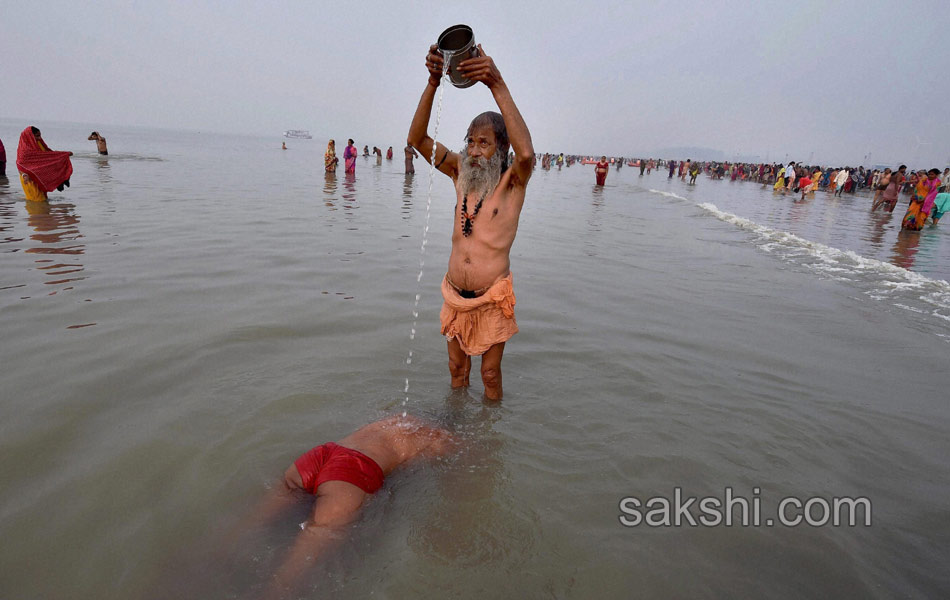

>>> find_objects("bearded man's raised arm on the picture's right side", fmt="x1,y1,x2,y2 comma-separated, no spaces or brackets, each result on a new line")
459,44,534,186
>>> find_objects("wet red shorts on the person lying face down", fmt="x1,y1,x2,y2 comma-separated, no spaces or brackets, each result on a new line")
294,442,383,494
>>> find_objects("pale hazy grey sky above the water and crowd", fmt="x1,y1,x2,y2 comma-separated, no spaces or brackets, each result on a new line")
0,0,950,168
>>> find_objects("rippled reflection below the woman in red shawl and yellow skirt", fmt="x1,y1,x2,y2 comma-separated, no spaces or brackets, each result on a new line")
25,201,86,296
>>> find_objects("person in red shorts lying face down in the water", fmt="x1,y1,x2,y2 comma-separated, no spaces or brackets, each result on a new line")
257,415,457,597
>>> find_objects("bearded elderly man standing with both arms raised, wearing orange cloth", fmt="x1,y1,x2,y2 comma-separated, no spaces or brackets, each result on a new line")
408,45,534,400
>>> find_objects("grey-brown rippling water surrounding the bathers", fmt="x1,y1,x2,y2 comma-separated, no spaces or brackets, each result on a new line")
0,121,950,598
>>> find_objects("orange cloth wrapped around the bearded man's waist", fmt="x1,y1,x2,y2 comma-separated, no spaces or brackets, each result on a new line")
439,273,518,356
